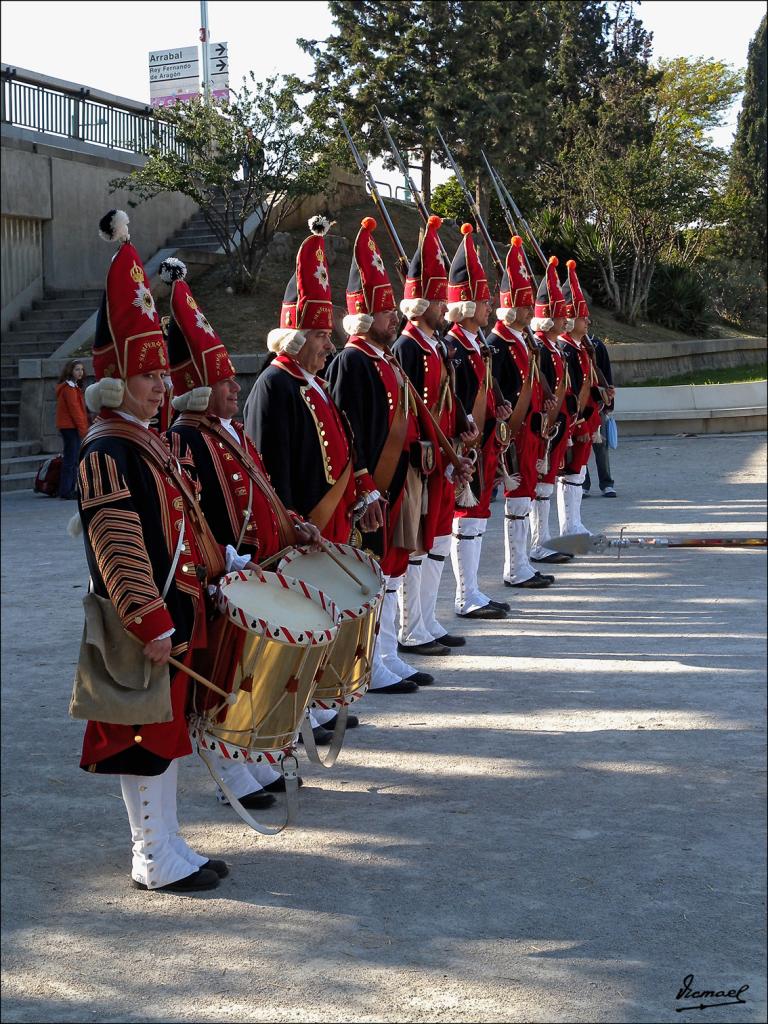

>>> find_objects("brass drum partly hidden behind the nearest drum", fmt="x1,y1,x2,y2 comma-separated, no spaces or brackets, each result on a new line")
279,543,384,709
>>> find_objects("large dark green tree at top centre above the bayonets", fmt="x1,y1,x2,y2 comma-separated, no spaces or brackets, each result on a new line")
299,0,546,218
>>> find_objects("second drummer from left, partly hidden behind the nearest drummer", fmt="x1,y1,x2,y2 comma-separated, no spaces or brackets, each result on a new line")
160,258,319,809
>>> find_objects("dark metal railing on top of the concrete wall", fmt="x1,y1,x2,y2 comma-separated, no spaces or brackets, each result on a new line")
0,65,184,156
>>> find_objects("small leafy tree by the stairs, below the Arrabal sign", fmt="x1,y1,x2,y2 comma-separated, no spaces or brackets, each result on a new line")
111,72,328,291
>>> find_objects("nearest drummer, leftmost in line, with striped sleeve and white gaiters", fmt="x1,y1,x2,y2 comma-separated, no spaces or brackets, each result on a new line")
71,210,243,893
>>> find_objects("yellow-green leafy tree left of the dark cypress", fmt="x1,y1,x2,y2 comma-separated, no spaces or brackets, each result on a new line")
566,57,740,323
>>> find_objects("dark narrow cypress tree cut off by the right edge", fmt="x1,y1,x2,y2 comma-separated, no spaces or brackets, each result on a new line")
726,17,768,264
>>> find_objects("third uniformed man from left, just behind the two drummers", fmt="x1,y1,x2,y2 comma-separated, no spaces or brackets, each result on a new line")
244,217,368,742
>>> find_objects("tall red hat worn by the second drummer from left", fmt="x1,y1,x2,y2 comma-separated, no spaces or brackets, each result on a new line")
160,258,234,412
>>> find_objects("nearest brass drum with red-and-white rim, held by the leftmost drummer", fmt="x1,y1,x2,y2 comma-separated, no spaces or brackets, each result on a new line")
189,569,338,764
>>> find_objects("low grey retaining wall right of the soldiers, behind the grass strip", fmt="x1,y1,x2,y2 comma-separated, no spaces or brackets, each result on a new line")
607,338,766,386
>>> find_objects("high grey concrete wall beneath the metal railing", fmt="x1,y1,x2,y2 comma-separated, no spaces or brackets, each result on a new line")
0,125,197,292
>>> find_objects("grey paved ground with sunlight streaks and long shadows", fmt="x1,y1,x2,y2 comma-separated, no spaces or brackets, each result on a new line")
2,435,766,1024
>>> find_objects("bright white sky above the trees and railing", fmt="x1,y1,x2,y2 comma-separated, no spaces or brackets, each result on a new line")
0,0,765,190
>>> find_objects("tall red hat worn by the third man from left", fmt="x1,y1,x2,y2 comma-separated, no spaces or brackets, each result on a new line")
280,216,334,331
